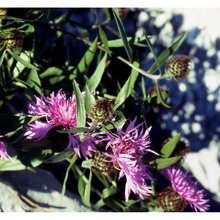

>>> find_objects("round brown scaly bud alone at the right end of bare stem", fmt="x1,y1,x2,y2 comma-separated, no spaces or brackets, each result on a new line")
167,55,192,80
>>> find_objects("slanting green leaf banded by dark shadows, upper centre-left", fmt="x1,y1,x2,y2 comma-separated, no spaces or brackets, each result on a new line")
70,38,98,80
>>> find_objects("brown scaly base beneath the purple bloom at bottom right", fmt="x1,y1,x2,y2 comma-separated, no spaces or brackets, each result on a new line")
156,186,188,212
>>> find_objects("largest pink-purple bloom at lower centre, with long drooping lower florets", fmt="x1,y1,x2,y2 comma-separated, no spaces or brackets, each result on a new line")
99,119,155,201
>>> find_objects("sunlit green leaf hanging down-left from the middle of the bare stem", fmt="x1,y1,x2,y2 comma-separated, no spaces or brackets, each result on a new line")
114,51,139,110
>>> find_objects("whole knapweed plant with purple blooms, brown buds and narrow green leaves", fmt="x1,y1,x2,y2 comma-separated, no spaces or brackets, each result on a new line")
0,8,209,212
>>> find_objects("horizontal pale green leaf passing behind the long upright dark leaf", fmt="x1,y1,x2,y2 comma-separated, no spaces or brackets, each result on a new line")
108,36,150,48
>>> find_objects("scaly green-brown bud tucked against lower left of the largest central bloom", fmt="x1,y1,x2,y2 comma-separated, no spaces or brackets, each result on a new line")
92,151,114,176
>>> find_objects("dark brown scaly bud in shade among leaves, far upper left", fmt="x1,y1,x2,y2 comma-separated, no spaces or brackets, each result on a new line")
7,30,24,50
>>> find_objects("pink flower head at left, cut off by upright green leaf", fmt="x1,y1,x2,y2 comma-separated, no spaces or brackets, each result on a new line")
25,91,77,139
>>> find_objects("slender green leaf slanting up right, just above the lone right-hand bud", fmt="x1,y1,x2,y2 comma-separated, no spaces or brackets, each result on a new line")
148,32,187,74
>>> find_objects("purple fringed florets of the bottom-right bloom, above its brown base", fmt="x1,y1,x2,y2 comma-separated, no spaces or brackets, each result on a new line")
161,166,209,212
